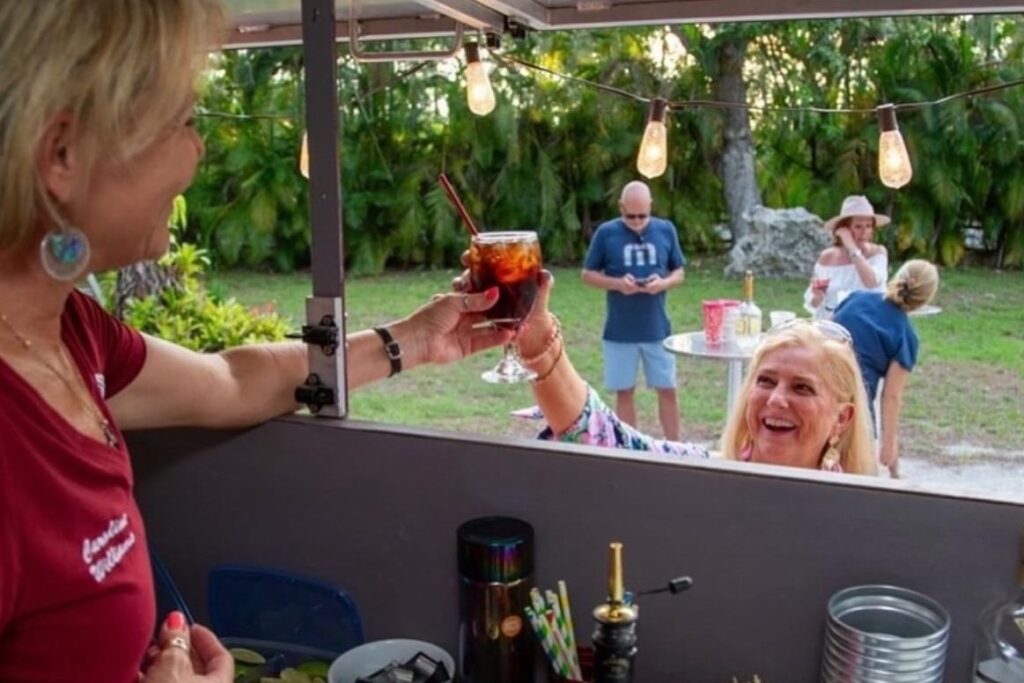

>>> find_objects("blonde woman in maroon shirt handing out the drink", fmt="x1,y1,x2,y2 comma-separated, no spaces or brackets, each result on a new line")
0,0,510,683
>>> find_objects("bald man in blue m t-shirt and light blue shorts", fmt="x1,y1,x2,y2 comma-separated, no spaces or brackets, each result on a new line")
583,180,686,441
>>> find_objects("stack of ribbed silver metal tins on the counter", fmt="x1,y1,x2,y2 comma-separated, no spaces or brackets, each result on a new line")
821,586,949,683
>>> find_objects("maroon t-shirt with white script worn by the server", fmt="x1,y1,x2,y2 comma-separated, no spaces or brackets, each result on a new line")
0,293,156,683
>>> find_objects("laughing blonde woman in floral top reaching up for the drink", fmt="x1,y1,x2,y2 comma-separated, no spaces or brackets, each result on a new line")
477,272,876,475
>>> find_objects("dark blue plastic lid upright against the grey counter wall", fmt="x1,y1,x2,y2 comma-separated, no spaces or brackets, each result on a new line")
207,565,365,654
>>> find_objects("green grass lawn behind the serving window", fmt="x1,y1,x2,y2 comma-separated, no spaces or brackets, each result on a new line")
210,258,1024,462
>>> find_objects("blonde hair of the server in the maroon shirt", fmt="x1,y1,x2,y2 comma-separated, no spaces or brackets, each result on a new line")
0,0,224,249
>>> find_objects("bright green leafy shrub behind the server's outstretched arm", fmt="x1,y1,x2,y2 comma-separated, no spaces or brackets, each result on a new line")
118,197,288,351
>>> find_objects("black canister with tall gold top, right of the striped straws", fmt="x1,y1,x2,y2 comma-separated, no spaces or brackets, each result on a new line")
593,543,639,683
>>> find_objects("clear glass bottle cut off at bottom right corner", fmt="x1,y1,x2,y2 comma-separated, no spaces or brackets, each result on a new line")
974,538,1024,683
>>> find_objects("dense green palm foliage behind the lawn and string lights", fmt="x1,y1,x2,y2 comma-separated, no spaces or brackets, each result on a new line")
186,16,1024,273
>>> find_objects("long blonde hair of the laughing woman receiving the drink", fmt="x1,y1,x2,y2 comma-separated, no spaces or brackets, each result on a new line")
721,323,877,474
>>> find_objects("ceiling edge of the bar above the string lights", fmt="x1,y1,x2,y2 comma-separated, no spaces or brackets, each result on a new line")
225,0,1024,45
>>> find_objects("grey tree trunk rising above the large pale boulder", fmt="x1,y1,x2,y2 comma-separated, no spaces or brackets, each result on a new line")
713,36,761,244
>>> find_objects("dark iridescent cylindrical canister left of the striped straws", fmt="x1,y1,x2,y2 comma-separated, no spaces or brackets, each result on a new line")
457,517,535,683
